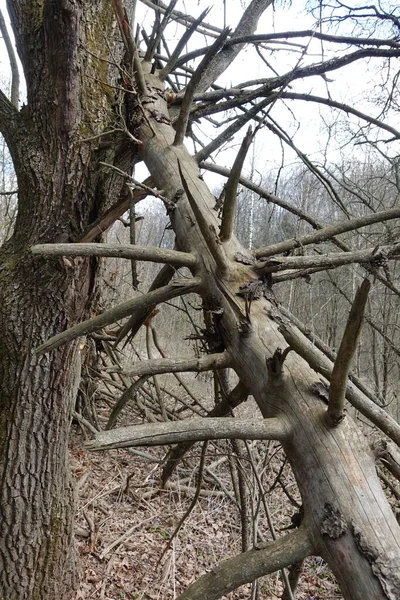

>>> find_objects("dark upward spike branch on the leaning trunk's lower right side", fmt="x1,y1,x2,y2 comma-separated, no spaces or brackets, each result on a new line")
327,279,371,425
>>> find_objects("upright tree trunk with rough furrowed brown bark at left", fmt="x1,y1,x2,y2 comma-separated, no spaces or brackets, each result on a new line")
0,0,132,600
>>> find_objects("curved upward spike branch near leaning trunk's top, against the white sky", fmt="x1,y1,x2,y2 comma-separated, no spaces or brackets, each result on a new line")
174,29,230,146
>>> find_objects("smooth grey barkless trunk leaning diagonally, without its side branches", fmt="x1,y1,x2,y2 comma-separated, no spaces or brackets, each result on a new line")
140,75,400,600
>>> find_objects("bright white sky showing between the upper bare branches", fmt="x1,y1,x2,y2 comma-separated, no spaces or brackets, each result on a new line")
0,0,400,180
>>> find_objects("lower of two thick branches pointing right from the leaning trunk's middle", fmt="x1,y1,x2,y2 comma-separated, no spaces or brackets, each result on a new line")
254,244,400,274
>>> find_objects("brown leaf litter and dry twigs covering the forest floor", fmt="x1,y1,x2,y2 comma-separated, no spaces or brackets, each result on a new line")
71,398,342,600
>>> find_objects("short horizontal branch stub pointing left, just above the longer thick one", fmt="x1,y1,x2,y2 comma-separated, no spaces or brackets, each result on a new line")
114,352,231,377
